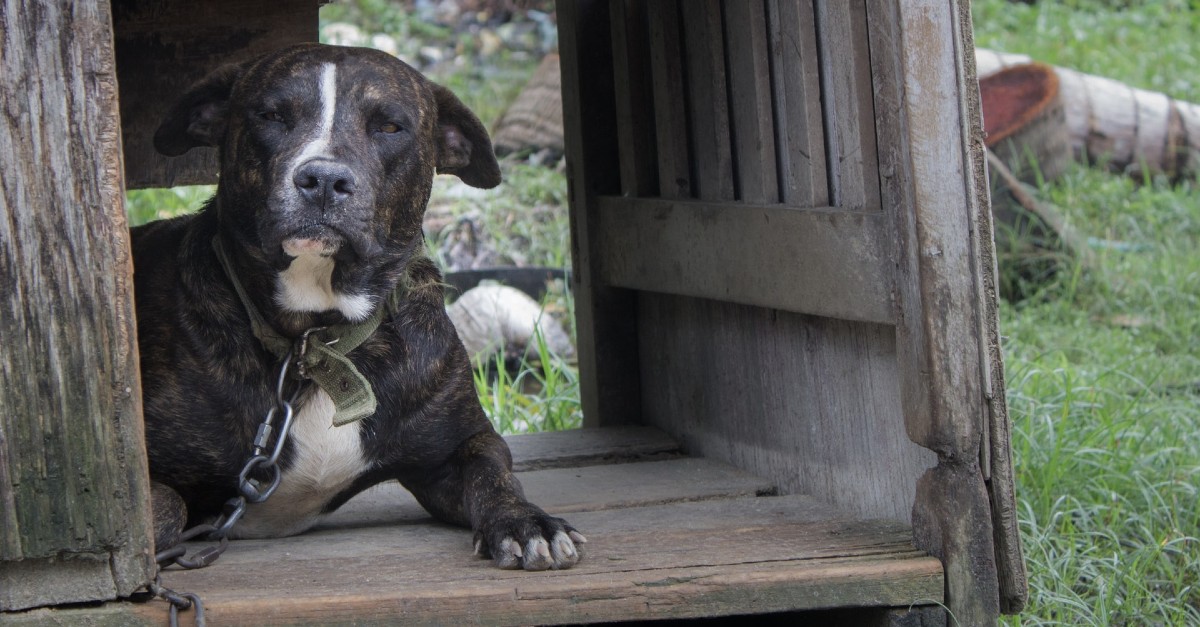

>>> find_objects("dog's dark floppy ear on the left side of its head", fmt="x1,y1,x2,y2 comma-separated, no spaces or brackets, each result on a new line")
154,64,248,156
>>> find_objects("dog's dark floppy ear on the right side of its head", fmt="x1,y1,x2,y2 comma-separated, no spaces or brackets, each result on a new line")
433,84,500,190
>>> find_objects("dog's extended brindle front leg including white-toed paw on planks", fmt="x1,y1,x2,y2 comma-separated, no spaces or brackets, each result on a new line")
404,430,587,571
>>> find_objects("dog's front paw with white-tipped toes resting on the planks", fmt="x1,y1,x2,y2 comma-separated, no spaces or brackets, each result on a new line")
475,503,588,571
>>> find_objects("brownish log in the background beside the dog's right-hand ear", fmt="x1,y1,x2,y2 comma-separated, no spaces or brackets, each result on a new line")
492,53,563,163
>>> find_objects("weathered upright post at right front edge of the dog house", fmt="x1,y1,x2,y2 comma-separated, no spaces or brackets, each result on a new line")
869,0,1025,625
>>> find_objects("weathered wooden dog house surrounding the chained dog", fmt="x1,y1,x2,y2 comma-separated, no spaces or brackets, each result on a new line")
0,0,1026,626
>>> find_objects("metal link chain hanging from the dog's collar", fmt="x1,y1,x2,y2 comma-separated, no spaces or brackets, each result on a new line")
148,327,324,627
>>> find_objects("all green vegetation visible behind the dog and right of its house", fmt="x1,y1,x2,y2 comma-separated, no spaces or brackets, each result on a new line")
130,0,1200,626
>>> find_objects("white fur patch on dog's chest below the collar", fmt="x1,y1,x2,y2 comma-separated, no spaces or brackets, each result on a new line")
230,389,368,538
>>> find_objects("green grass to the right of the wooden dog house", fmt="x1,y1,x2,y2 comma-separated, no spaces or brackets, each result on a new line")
973,0,1200,626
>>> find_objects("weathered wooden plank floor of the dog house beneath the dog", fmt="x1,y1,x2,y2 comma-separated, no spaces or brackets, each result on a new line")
14,429,942,625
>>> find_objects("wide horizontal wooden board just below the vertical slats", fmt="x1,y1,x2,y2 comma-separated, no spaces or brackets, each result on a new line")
598,197,895,323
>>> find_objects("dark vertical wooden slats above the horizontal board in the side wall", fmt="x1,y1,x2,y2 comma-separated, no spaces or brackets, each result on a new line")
613,0,880,210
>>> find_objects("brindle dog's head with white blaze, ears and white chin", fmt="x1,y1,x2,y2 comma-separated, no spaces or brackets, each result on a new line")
155,44,500,320
